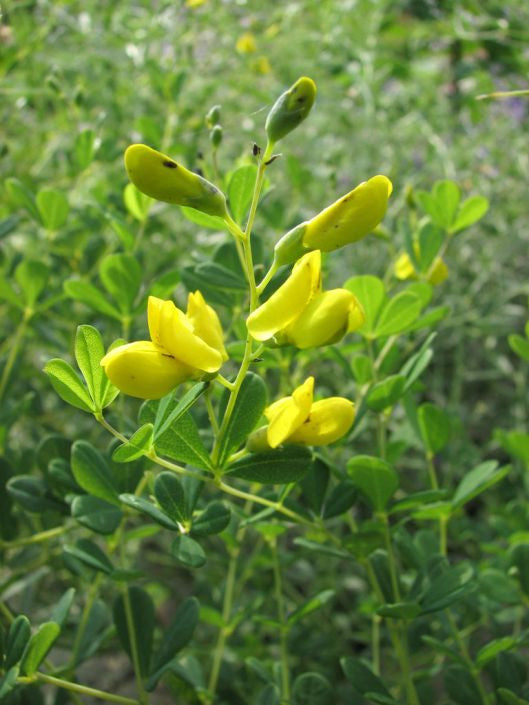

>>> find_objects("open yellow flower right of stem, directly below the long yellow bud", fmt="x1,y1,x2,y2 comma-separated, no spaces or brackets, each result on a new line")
247,250,365,350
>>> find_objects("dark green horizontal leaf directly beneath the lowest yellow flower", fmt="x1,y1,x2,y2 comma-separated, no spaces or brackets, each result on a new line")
227,446,312,485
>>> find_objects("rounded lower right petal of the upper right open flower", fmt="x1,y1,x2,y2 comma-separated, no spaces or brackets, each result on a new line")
277,289,364,350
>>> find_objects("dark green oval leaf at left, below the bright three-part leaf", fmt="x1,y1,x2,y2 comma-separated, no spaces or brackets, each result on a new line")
71,441,119,506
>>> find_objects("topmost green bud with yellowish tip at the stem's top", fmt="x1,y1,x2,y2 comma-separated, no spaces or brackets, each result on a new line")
265,76,316,144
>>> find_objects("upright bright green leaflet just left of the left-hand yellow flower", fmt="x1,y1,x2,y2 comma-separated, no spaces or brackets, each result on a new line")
75,325,115,411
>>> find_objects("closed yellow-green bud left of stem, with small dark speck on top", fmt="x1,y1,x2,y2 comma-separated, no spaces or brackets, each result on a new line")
125,144,226,217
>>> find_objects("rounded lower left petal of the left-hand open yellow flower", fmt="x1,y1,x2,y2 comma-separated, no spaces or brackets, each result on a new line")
101,340,196,399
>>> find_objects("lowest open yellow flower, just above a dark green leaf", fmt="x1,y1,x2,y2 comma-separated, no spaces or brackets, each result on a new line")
247,377,355,451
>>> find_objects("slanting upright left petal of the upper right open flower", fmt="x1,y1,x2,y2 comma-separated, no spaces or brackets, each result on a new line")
246,250,321,340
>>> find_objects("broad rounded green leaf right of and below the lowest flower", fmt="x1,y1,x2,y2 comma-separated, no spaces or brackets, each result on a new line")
347,455,399,512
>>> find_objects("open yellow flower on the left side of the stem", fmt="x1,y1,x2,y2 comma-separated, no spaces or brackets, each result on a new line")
101,291,228,399
